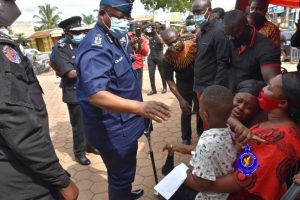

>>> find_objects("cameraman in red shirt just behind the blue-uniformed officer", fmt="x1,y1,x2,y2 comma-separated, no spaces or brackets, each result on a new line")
128,22,149,91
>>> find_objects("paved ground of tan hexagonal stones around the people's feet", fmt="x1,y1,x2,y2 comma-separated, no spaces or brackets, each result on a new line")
38,63,296,200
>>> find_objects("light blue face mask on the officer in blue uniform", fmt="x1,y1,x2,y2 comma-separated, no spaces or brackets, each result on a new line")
109,17,130,39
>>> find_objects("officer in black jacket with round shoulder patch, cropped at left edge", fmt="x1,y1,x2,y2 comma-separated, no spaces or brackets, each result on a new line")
0,0,78,200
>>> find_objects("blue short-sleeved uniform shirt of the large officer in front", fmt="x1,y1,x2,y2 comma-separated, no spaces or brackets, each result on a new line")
76,24,145,150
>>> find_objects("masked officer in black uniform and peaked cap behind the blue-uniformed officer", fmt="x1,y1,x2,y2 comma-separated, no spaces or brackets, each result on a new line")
51,16,99,165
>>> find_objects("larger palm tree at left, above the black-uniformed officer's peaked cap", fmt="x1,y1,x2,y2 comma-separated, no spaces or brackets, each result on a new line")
33,4,61,30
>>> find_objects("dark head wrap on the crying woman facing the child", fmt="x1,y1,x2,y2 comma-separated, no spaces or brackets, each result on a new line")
235,79,266,97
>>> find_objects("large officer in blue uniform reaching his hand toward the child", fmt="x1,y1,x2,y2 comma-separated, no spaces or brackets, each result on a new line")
76,0,169,200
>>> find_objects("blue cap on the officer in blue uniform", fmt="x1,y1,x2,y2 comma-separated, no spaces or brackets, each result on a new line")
100,0,134,15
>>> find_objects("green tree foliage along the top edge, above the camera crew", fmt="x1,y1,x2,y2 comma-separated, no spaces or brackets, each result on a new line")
141,0,194,12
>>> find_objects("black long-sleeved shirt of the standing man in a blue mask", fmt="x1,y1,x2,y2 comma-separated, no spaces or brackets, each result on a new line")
194,20,230,92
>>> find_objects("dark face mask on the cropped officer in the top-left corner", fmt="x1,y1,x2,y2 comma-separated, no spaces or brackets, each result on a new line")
0,0,21,26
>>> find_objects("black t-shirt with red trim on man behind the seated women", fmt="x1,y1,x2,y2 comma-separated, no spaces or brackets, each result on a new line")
229,30,281,89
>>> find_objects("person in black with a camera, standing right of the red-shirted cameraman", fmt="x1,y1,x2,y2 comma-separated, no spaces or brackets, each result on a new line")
144,22,167,96
